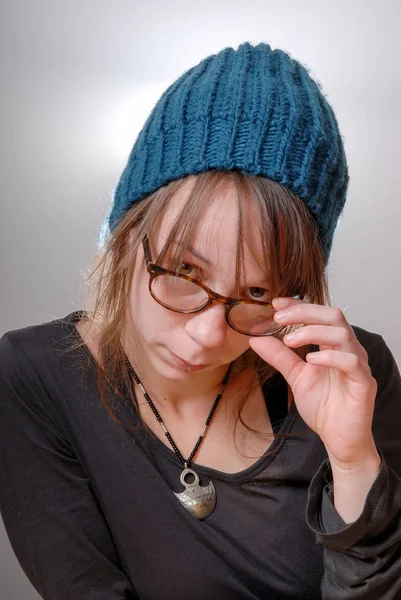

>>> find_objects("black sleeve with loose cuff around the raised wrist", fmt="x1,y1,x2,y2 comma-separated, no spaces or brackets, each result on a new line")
307,337,401,600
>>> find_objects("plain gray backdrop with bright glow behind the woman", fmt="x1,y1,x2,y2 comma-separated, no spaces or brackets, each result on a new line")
0,0,401,600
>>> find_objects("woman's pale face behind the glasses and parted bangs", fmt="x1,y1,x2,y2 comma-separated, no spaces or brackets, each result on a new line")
129,178,268,381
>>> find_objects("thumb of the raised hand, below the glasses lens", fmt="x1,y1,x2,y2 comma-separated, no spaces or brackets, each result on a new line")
249,336,305,387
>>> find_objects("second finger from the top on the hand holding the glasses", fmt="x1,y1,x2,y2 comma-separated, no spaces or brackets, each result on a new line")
283,325,366,360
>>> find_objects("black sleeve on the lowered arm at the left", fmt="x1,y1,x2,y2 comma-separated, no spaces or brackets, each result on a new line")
0,334,137,600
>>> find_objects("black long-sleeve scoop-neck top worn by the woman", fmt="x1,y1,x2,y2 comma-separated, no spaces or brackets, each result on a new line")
0,313,401,600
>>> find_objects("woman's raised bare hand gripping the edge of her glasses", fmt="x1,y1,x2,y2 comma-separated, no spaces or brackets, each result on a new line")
249,298,379,469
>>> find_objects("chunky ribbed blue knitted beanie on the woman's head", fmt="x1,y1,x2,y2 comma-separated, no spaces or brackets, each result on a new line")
109,43,348,263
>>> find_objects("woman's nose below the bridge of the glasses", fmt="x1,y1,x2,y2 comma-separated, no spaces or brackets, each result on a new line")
185,303,228,348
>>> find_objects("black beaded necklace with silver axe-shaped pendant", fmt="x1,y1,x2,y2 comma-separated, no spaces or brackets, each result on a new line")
125,356,232,520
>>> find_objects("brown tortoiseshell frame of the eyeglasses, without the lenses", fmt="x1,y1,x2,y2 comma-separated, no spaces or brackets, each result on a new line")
142,235,285,337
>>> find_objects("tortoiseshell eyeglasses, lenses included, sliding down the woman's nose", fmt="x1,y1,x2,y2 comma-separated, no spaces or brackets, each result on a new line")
142,236,290,337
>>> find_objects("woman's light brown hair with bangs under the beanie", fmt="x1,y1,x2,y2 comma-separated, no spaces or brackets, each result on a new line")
74,170,329,462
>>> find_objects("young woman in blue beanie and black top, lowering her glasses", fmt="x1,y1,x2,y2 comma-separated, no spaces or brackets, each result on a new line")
0,43,401,600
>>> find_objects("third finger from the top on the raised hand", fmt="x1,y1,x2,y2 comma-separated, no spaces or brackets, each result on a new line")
306,350,375,383
